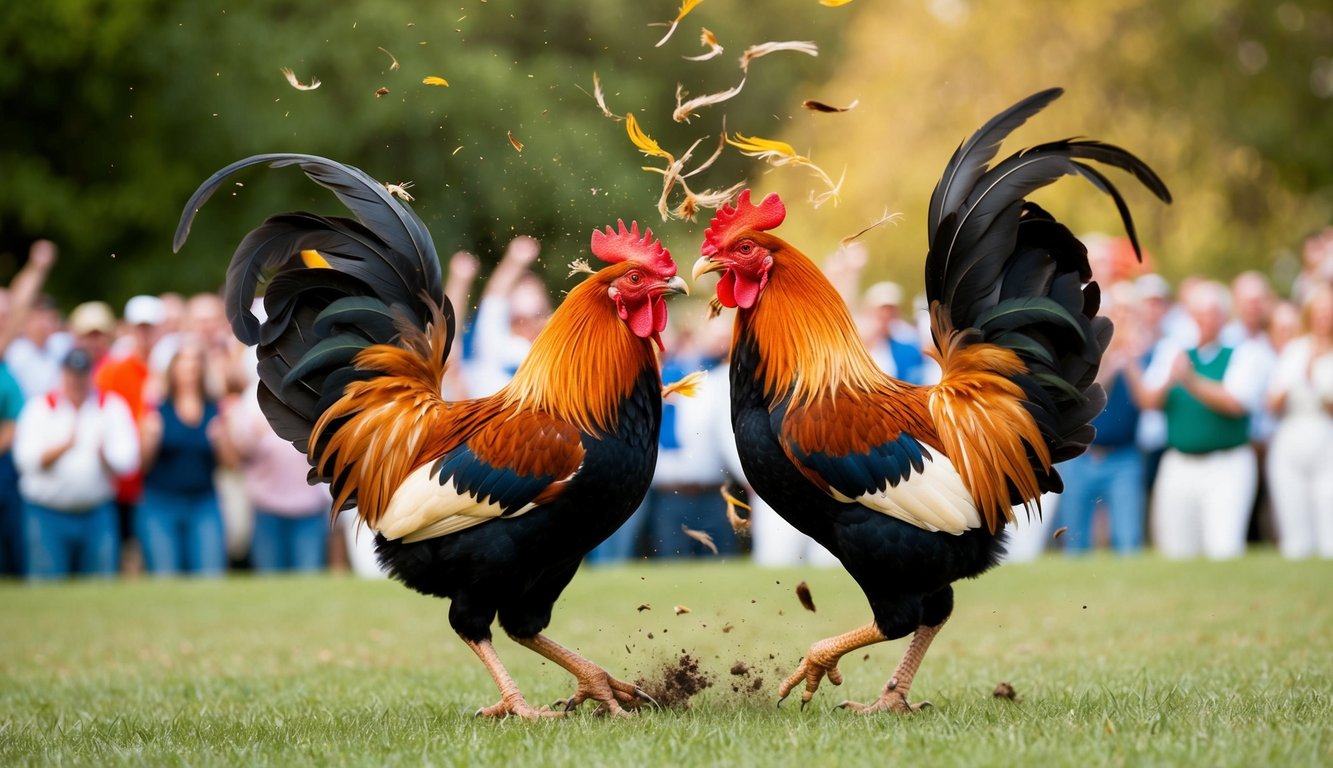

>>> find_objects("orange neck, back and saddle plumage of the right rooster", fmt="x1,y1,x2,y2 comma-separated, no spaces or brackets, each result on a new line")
736,232,1050,531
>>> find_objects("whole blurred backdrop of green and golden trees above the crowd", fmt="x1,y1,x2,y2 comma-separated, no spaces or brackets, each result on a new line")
0,0,1333,309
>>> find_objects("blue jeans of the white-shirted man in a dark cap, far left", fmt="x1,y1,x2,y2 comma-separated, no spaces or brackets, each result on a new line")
23,500,120,579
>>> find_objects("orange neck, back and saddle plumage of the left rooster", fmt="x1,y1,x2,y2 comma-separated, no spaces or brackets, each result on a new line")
311,263,657,528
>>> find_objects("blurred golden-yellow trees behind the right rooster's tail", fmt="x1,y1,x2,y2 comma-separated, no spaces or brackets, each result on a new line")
774,0,1333,298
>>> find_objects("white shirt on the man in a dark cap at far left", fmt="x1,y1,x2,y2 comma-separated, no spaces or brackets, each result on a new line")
13,392,139,511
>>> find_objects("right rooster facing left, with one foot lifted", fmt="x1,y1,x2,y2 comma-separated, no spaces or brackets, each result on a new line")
693,89,1170,713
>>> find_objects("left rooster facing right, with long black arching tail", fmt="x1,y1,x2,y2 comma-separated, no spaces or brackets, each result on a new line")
175,155,688,719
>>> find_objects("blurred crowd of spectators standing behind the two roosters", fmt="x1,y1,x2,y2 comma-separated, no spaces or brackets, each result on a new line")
0,228,1333,579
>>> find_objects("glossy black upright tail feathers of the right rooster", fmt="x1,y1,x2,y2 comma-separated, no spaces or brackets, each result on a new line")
925,89,1170,490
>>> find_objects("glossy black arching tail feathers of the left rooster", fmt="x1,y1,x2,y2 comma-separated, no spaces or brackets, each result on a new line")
173,155,453,469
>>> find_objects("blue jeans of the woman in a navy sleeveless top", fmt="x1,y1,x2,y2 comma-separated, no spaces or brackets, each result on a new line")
135,488,227,576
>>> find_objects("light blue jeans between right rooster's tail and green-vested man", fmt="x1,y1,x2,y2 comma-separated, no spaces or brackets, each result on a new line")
1056,445,1146,555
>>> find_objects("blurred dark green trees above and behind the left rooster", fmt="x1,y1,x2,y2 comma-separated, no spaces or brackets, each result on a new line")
0,0,845,307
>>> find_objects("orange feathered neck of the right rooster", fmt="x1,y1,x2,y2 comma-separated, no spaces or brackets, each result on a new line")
736,243,886,403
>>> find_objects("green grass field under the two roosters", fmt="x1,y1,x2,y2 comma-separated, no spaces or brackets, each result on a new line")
0,553,1333,768
